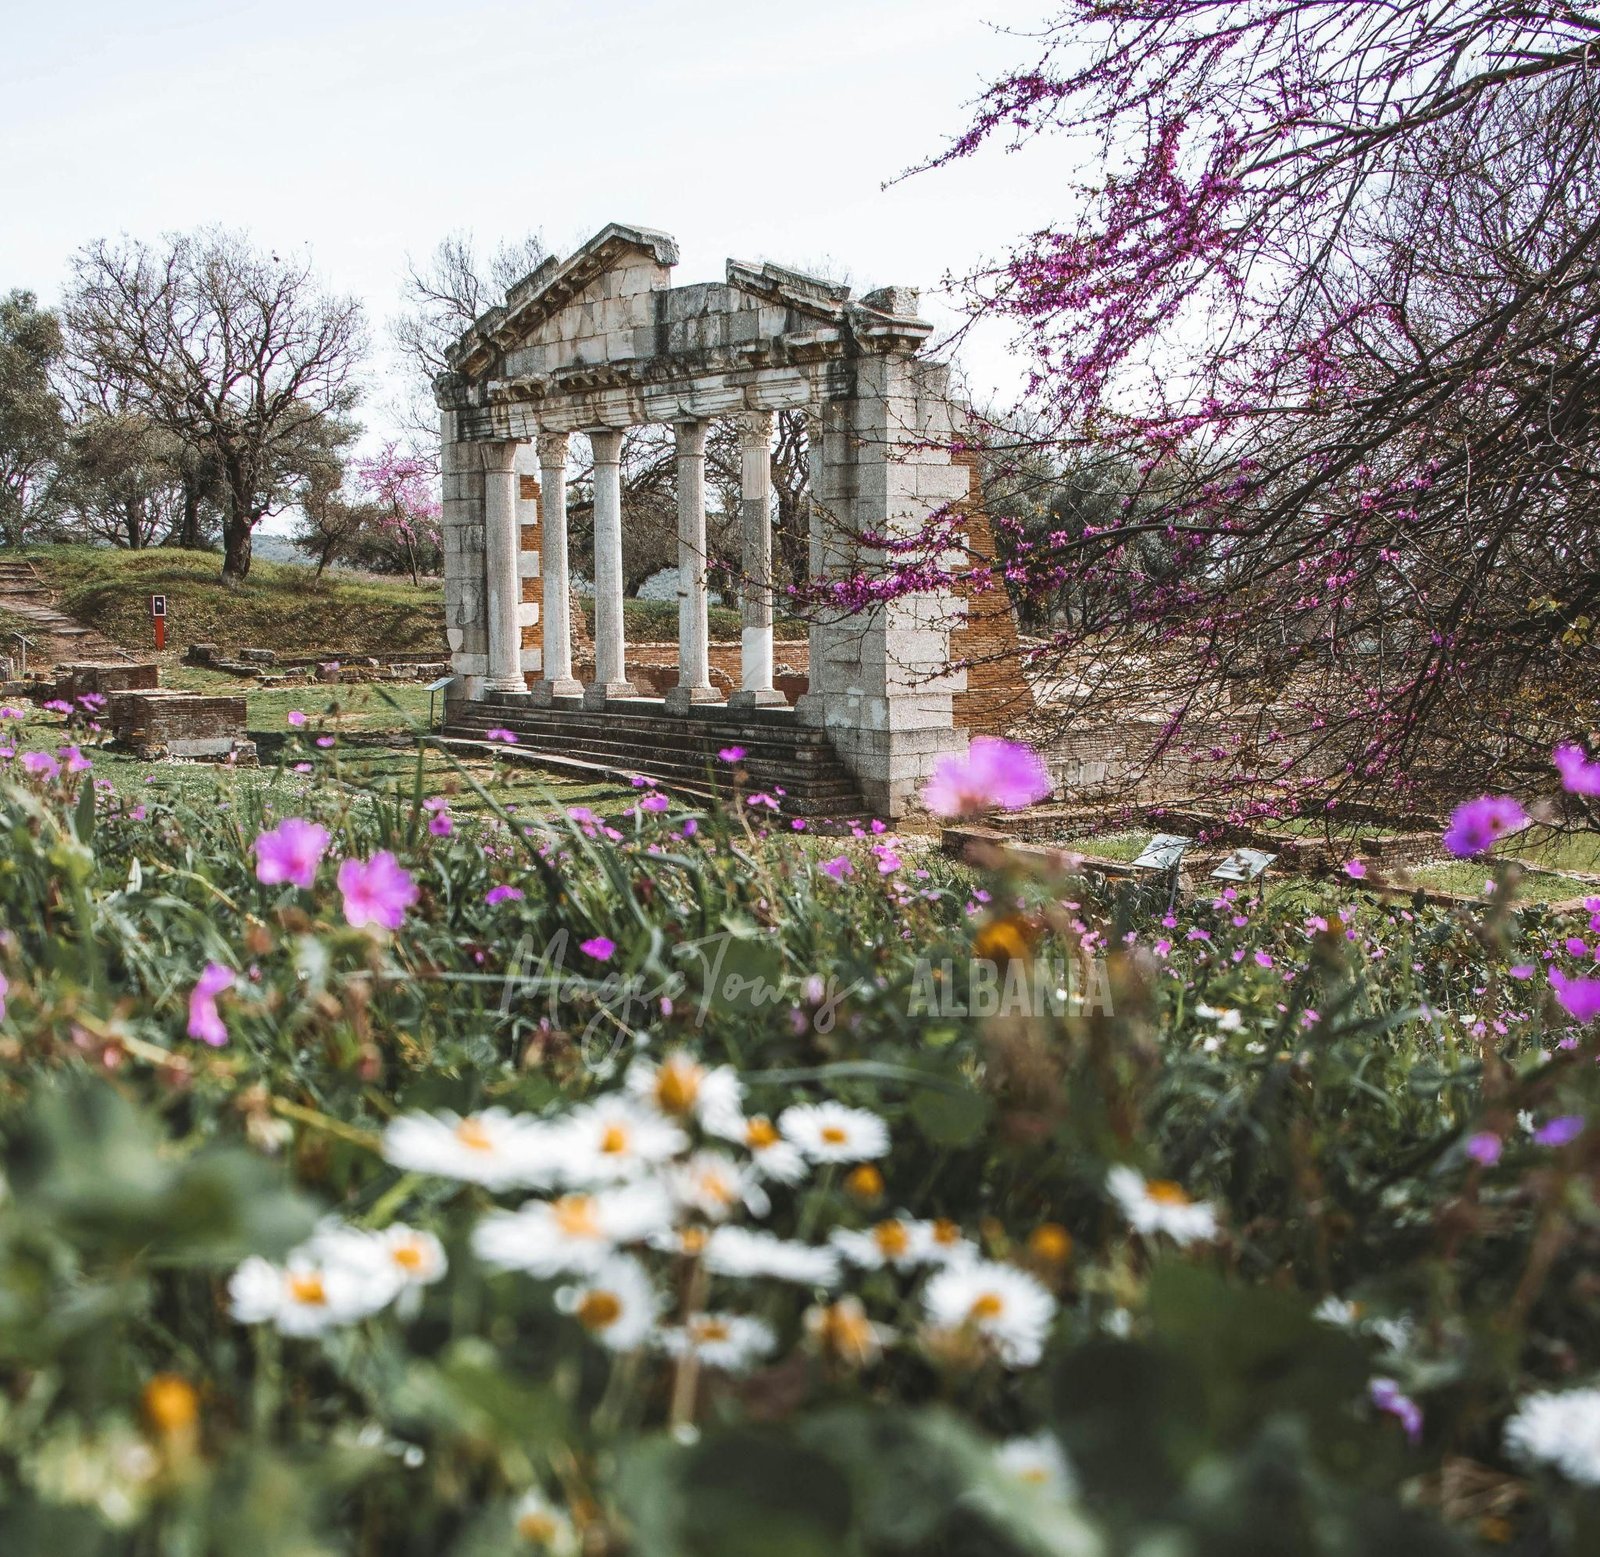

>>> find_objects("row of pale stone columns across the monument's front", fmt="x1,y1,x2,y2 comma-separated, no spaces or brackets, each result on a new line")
480,411,786,712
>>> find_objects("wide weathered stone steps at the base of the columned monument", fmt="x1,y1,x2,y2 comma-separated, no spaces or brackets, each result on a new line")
445,693,864,819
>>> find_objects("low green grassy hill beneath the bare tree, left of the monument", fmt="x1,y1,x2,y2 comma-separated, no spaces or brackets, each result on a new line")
21,546,445,654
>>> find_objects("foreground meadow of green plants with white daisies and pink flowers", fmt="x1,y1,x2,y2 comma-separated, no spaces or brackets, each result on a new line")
0,732,1600,1557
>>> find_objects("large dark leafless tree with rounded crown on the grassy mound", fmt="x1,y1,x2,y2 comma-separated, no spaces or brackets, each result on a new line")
64,229,365,582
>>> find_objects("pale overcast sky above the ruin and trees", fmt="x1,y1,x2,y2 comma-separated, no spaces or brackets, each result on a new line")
0,0,1074,486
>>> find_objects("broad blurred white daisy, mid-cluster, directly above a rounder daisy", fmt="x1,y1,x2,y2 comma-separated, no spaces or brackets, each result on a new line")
472,1181,672,1277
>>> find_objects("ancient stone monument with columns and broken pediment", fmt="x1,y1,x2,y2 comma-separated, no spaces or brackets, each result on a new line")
435,224,1014,816
